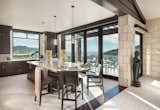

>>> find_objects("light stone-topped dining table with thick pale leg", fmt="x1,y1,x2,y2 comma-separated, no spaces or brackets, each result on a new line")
27,61,89,101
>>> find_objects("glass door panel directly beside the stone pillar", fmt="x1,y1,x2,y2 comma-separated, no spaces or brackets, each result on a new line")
103,34,118,77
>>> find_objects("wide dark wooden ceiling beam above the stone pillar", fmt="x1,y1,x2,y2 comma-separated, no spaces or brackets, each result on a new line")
92,0,146,24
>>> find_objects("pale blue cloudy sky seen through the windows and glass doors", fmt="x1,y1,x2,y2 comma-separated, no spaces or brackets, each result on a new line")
13,33,140,52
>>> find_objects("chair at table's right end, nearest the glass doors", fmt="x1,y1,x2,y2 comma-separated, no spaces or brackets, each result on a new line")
86,64,104,94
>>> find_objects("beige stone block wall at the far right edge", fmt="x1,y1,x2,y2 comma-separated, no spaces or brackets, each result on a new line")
143,18,160,77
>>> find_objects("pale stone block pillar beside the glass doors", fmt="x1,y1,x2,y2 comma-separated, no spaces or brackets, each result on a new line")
118,15,145,87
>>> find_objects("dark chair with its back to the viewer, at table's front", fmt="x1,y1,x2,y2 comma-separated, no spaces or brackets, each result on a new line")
61,71,83,110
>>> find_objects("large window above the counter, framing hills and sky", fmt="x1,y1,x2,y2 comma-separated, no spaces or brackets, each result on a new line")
12,31,39,60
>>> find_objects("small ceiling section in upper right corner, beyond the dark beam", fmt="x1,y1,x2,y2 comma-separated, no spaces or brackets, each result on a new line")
136,0,160,19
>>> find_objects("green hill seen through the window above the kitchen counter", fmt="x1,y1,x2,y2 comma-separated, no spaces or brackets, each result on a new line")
13,46,38,54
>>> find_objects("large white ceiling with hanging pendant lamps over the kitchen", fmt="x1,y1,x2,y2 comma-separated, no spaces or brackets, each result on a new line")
0,0,114,32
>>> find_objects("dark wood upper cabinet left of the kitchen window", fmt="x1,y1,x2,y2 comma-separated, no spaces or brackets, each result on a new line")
0,25,12,54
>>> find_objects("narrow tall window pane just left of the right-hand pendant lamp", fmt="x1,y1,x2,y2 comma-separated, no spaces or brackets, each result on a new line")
65,35,72,62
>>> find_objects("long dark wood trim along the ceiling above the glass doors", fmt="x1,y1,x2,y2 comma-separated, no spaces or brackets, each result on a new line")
57,16,118,34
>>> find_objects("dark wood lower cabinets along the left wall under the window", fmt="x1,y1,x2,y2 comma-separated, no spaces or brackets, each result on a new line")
0,61,29,77
